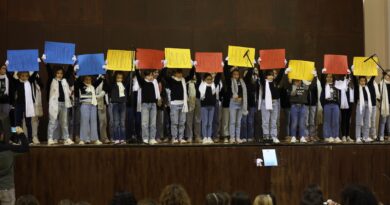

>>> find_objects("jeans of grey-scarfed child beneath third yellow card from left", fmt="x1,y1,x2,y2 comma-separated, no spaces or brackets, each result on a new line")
229,99,242,139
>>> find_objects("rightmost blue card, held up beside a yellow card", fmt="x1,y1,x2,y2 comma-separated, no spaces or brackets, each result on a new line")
77,53,106,76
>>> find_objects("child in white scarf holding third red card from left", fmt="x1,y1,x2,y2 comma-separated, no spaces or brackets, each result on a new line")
259,69,284,143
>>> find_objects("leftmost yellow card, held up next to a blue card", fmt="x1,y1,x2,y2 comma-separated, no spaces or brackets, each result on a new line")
107,50,135,71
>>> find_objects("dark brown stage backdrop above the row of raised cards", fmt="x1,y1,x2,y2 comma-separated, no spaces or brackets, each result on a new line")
0,0,364,138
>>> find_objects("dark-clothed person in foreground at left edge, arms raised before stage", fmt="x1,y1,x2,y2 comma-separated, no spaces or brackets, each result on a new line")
0,127,29,205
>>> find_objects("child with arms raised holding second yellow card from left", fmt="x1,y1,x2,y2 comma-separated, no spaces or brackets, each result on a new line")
161,67,195,144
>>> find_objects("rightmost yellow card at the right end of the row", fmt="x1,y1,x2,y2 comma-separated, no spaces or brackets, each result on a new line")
353,57,378,76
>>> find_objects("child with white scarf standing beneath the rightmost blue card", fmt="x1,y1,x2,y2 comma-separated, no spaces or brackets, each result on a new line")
76,76,102,145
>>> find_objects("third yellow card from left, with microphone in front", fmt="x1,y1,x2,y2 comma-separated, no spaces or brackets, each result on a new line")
228,46,255,68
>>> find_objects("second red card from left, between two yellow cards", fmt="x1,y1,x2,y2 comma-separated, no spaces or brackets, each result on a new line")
195,52,223,73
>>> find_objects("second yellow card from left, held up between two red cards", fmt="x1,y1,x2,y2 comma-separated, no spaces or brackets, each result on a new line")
165,48,192,68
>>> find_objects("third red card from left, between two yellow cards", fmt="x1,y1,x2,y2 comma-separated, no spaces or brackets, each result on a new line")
259,49,286,70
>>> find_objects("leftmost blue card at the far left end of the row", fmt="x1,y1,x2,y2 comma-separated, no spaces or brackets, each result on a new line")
7,49,39,71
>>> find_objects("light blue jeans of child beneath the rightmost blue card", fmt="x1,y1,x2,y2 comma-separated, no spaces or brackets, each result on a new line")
80,104,99,142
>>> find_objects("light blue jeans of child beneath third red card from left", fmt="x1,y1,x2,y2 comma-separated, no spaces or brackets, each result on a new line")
261,100,280,138
